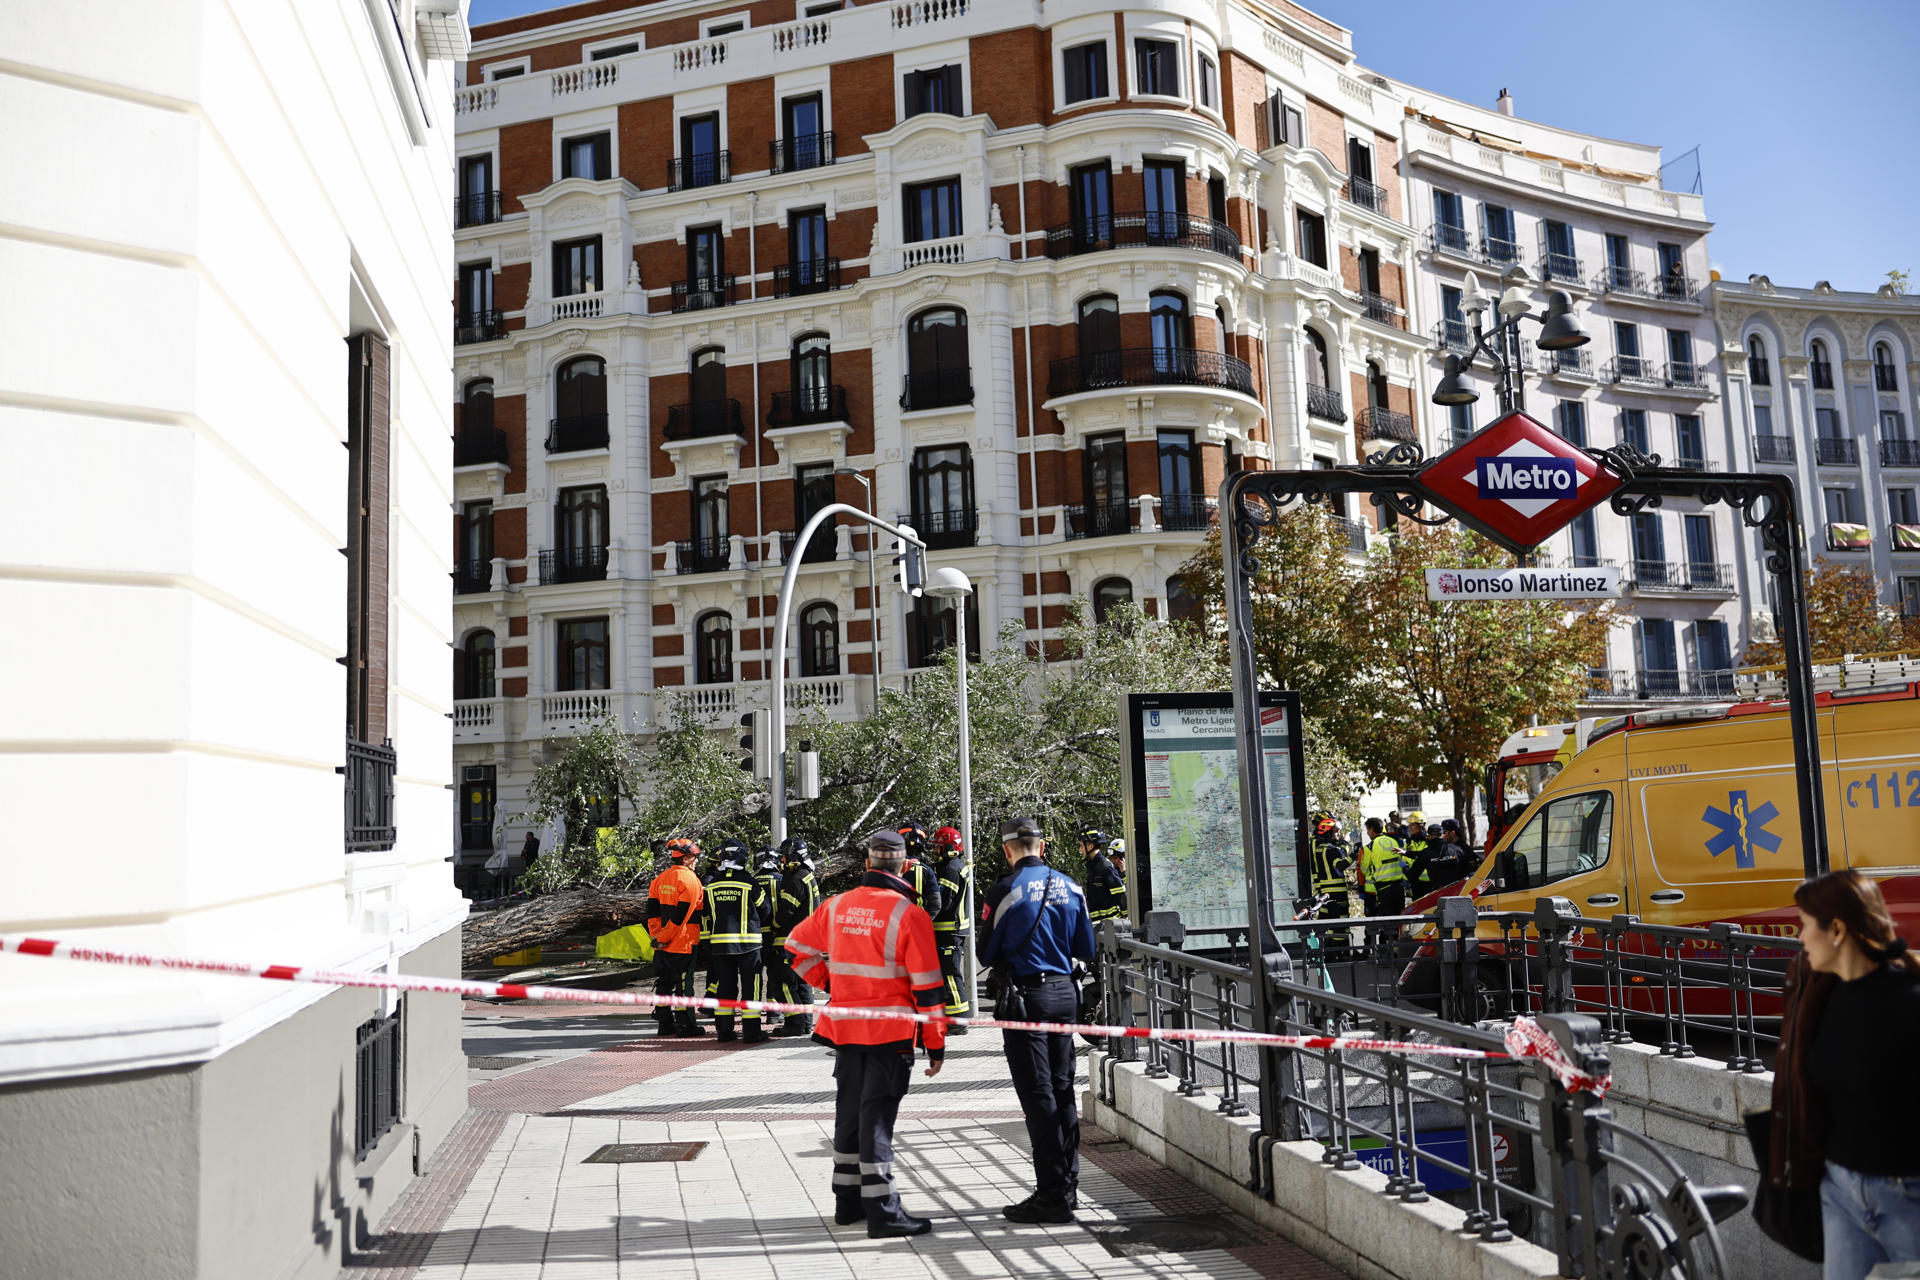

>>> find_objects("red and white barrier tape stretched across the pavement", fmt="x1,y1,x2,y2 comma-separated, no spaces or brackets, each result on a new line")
0,935,1613,1096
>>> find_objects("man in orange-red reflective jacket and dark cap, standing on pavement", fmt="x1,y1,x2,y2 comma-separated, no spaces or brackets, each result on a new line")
787,829,947,1240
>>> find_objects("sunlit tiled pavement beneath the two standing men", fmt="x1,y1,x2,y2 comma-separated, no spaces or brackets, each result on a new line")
342,1006,1340,1280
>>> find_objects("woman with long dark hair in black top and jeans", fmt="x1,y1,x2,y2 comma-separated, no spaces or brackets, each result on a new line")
1766,871,1920,1280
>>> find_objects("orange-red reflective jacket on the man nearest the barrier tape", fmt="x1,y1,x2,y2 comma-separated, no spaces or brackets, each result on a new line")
787,871,947,1061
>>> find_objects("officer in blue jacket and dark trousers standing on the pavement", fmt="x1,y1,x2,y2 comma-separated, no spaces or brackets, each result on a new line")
975,818,1094,1222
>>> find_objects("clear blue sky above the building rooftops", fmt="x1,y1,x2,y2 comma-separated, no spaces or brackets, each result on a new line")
472,0,1920,290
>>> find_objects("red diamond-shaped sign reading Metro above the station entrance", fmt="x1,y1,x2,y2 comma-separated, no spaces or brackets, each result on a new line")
1421,413,1620,551
